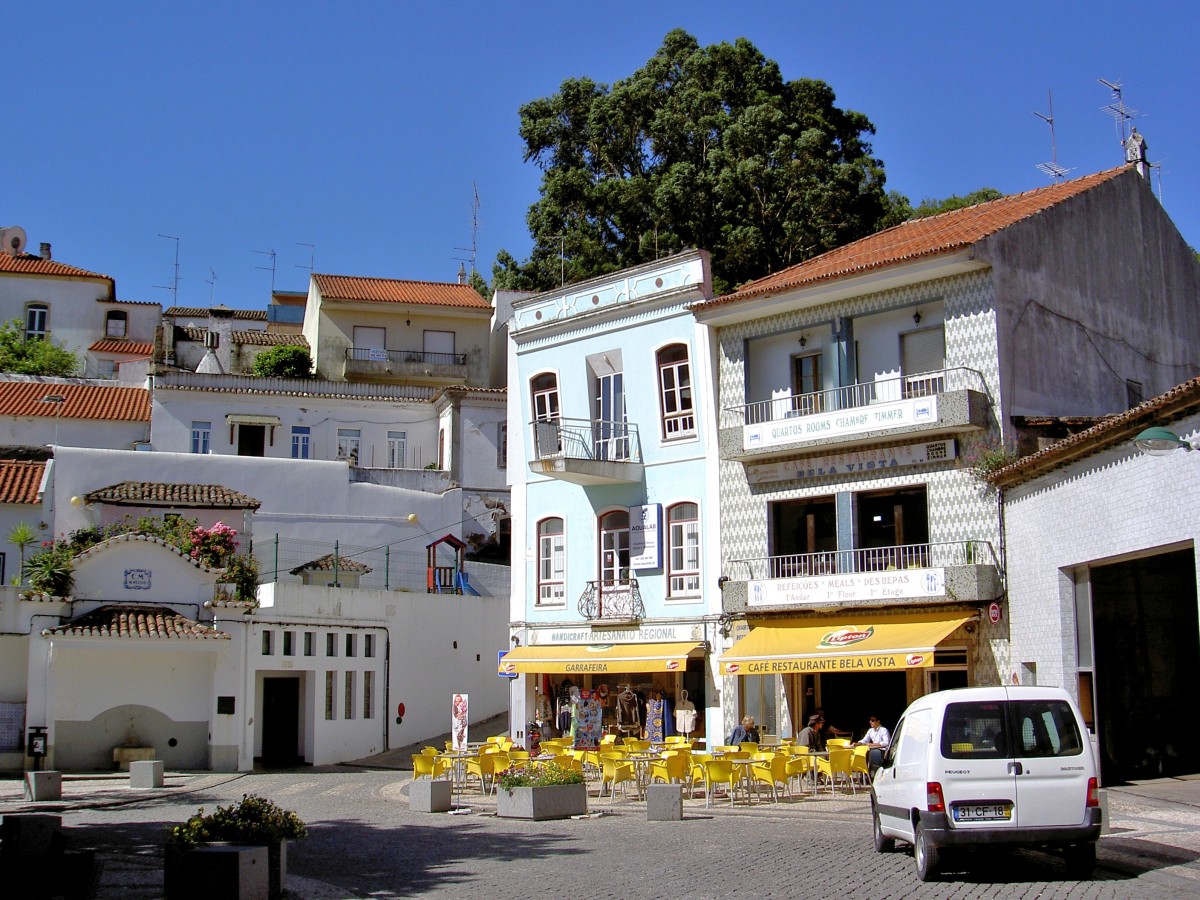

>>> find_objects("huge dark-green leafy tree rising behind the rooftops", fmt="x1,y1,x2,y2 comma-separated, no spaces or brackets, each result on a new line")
493,30,893,290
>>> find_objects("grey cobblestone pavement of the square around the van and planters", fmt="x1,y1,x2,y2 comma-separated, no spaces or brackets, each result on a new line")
0,767,1200,900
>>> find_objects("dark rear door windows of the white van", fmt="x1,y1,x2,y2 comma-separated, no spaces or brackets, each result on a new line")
942,700,1084,760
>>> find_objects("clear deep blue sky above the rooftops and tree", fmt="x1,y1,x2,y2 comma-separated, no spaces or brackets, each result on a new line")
0,0,1200,308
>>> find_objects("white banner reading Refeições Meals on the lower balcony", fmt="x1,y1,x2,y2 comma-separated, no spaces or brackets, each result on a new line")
746,569,946,606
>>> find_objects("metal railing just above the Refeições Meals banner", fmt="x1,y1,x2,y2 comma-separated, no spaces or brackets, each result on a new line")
730,541,998,581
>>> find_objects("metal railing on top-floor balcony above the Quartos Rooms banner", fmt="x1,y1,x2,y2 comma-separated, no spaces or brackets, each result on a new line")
721,366,988,428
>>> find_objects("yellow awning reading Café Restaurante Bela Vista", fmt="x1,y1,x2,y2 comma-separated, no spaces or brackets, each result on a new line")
721,610,976,676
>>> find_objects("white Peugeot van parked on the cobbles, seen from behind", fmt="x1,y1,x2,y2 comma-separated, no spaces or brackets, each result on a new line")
871,686,1100,881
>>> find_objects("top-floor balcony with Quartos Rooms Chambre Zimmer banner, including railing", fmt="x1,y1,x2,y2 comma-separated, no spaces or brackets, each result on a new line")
720,367,991,462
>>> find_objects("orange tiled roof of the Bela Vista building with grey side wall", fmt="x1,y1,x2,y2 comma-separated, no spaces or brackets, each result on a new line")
689,166,1132,311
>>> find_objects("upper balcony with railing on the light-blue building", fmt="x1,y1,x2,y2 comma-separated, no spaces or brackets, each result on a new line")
529,419,643,485
